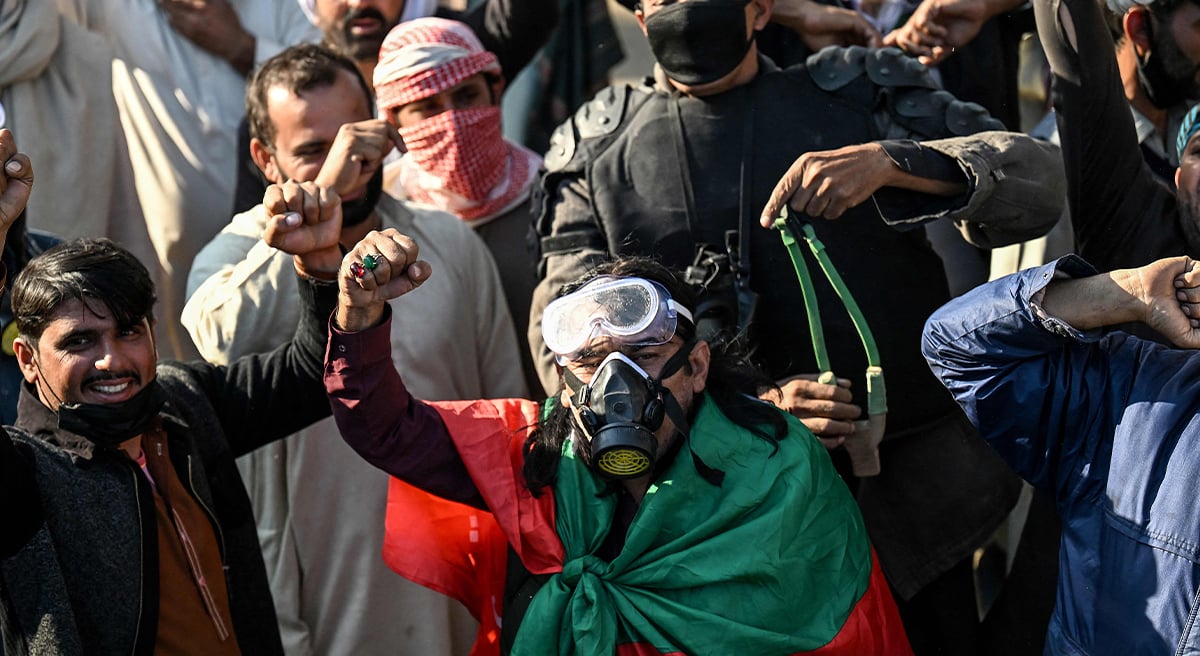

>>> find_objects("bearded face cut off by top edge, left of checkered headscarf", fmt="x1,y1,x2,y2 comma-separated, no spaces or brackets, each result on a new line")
314,0,404,62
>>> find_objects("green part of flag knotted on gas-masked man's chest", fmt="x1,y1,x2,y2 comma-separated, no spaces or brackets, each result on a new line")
512,396,871,656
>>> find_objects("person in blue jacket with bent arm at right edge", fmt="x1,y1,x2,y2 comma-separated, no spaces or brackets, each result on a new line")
923,255,1200,654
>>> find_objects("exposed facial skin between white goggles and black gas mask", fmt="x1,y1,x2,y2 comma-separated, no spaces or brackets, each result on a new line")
563,335,710,451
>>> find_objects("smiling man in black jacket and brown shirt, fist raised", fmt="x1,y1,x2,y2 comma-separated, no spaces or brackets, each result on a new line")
0,125,340,655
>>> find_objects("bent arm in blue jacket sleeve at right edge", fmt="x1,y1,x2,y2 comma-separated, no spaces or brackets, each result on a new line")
923,257,1200,498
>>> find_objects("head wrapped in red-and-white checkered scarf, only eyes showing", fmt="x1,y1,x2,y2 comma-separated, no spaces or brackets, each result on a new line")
374,18,540,221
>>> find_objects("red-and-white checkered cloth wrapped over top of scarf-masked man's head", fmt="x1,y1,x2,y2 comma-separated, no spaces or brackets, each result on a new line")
374,18,500,114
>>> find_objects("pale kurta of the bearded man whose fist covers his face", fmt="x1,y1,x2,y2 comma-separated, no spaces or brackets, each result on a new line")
184,195,524,656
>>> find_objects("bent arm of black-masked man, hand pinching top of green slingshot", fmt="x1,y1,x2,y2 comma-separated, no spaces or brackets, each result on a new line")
761,48,1064,247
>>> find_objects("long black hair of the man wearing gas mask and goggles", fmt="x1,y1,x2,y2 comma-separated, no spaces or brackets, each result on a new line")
524,257,787,495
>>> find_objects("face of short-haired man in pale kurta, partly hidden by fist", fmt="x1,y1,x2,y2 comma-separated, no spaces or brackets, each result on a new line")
256,71,378,201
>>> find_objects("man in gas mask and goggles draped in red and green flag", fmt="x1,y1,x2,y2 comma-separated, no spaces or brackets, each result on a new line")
325,239,911,655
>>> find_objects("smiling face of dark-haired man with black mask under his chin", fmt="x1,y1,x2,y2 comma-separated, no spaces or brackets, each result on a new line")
13,299,158,409
